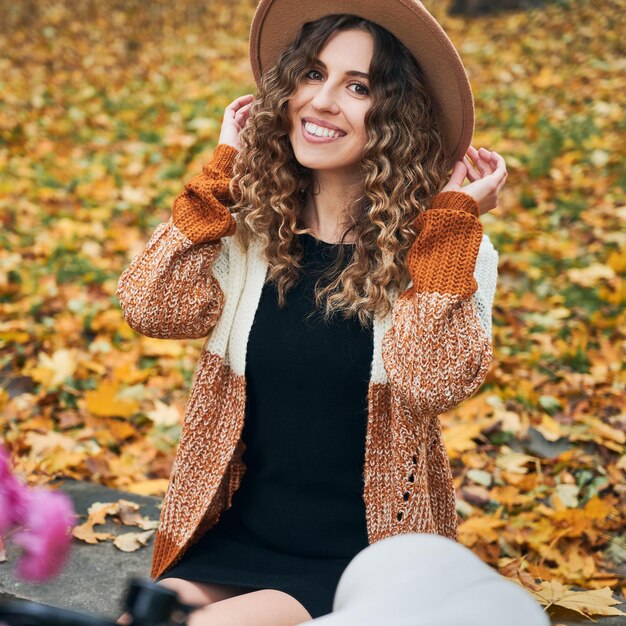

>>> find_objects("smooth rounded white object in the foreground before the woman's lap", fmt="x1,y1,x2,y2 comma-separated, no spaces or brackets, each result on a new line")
306,533,550,626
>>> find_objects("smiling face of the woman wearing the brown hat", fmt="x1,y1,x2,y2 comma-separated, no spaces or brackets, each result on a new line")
288,30,374,179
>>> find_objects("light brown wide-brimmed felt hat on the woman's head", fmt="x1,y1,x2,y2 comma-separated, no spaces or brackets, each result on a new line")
250,0,474,166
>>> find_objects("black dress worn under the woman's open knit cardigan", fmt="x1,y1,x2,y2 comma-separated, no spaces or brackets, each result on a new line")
156,234,373,618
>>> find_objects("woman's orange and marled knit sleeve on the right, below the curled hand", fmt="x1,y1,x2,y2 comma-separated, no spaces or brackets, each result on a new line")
382,192,493,417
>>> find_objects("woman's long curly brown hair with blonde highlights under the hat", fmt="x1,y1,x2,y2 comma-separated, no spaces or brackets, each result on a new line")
230,15,451,325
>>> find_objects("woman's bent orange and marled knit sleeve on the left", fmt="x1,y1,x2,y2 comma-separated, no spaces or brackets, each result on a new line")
117,144,237,339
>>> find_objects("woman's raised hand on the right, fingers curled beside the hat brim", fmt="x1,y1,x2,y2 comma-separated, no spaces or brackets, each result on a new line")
441,146,507,215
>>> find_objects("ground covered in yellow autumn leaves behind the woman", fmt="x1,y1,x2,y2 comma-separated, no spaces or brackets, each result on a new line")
0,0,626,616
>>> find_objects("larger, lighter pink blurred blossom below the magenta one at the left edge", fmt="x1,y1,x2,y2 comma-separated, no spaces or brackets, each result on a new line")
13,488,76,582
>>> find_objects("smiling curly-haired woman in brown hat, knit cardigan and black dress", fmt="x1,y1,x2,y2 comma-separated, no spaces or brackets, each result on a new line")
118,0,506,626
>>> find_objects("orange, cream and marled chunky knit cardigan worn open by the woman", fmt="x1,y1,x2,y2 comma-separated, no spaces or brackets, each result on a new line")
117,144,498,578
